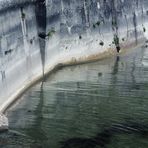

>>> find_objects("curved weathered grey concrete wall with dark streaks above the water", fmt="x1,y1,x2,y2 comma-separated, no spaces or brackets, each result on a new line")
0,0,148,111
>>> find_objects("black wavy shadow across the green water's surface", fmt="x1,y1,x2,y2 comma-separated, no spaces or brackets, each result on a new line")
61,123,148,148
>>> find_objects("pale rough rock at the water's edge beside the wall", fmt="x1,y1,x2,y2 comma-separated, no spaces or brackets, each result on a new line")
0,114,9,132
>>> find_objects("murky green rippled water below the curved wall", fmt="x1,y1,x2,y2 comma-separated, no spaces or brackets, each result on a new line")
0,48,148,148
